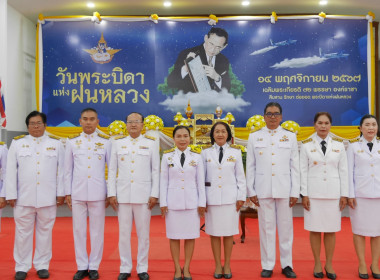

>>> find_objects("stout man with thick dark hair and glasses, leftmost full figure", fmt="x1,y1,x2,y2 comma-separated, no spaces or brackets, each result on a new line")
5,111,64,280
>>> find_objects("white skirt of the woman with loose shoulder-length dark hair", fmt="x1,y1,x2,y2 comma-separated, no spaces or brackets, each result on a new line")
205,203,239,236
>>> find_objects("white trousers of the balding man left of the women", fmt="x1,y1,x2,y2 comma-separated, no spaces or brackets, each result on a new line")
118,203,151,273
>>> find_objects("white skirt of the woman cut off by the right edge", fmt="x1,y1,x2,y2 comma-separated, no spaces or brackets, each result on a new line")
350,197,380,237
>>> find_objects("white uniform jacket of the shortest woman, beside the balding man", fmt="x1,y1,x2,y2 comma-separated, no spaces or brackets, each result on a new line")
160,148,206,210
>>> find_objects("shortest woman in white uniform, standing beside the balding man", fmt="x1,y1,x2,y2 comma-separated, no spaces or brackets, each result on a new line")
160,126,206,280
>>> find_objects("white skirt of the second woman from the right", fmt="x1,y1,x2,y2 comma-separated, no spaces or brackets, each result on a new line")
303,198,342,232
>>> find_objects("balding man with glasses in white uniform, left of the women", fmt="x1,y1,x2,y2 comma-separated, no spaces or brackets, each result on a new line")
108,113,160,280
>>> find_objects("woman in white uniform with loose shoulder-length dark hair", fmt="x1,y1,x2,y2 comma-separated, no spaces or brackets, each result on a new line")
202,122,247,279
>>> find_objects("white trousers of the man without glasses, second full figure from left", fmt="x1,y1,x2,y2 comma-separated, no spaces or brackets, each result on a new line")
72,200,105,270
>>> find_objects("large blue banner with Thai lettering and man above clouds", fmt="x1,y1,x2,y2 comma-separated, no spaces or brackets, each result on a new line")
40,18,369,127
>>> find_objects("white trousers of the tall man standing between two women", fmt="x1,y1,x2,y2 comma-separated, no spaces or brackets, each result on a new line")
258,198,293,270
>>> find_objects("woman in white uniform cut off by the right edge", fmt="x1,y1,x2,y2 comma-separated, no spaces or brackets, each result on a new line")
347,115,380,279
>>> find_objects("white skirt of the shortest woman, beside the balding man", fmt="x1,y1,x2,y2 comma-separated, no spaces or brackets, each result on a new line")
165,208,200,239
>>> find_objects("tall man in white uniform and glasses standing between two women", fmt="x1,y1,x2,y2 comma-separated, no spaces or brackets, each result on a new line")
246,102,300,278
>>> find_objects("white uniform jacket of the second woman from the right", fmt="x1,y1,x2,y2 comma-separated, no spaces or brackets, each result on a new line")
300,134,348,199
